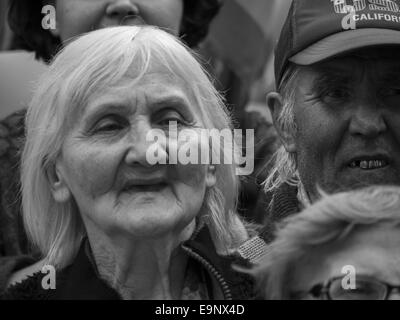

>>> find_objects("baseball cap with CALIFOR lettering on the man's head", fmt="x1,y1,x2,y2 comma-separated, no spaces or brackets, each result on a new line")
275,0,400,85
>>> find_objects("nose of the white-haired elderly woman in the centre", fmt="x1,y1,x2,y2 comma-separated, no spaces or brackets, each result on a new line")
125,121,168,167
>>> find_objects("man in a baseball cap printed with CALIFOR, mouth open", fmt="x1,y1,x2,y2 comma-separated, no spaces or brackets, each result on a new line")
265,0,400,240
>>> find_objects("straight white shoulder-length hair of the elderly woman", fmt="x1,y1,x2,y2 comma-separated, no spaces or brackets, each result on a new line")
21,26,243,268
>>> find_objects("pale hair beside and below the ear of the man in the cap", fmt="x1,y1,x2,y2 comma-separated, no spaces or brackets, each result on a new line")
263,64,300,192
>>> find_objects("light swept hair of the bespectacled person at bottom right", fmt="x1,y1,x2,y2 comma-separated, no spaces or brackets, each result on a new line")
251,186,400,300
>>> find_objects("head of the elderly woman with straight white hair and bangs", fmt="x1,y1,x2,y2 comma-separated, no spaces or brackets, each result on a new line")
22,27,242,266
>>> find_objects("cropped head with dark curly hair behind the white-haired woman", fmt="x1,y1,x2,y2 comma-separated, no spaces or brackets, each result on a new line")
9,0,222,61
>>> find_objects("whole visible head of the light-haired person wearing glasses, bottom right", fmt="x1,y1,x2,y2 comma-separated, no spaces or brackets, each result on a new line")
257,186,400,300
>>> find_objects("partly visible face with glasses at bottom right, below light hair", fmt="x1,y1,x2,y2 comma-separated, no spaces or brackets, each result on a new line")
289,225,400,300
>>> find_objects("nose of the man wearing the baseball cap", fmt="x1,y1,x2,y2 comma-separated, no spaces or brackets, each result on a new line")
350,101,386,138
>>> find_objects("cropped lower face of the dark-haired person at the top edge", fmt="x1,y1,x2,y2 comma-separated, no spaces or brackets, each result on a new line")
49,0,183,42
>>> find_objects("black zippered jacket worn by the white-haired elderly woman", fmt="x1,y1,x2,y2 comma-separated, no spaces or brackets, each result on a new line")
0,228,254,300
